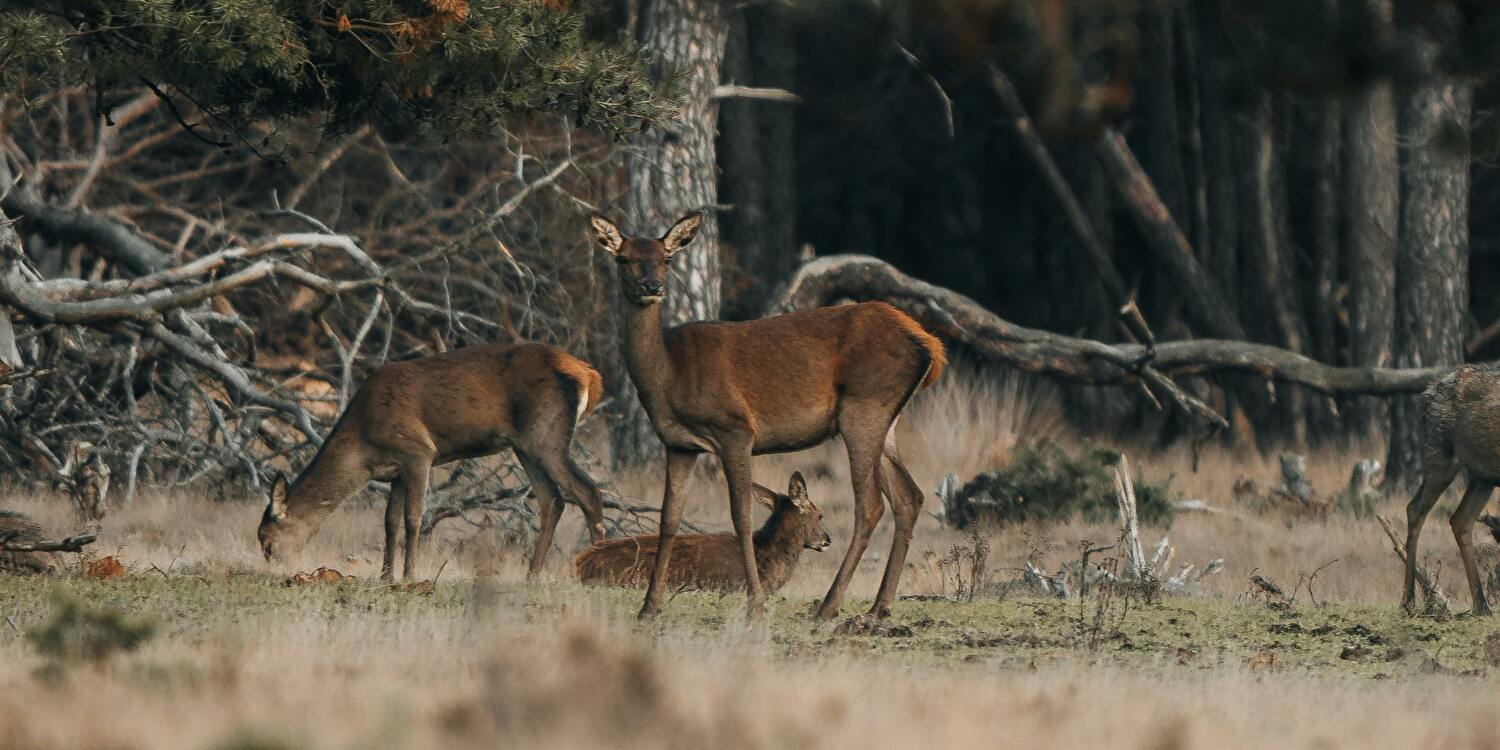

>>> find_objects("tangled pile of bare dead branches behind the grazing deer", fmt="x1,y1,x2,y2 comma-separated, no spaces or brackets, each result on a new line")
0,90,633,534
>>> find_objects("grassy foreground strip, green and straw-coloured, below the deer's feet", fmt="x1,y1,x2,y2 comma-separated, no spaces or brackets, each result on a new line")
0,572,1500,749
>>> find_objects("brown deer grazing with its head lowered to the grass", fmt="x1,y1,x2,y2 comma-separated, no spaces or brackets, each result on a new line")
260,344,605,579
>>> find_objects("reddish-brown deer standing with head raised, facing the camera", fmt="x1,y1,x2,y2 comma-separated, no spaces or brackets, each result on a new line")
590,213,947,618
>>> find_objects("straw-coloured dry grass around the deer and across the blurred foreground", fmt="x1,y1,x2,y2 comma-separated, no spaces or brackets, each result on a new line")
0,364,1500,749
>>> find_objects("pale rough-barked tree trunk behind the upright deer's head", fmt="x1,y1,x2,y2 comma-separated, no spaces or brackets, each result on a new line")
615,0,729,465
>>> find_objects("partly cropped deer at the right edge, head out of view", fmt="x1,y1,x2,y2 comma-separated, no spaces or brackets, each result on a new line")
1401,365,1500,615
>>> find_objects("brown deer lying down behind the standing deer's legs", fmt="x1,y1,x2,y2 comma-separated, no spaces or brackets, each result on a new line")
573,471,833,594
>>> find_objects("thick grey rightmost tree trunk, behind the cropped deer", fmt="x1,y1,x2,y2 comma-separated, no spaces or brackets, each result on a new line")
1386,81,1473,488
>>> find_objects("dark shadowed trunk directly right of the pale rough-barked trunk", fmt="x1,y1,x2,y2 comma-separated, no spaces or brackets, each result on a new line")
719,5,797,318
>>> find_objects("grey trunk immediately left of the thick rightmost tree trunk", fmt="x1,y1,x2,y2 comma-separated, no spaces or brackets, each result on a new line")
1344,0,1401,437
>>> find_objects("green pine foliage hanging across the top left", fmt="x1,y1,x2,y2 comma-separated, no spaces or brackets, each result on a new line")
0,0,675,137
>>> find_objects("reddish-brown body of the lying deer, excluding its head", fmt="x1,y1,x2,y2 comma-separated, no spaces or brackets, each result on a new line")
573,533,801,594
